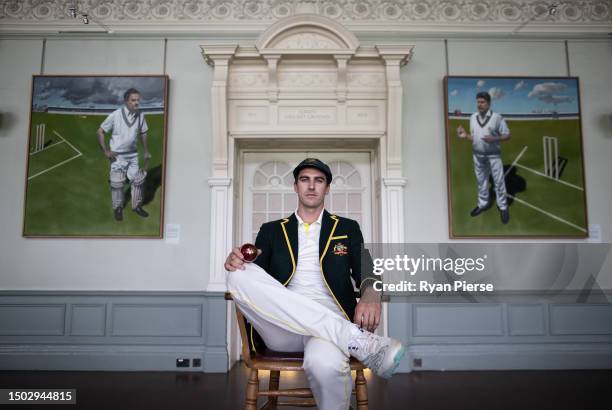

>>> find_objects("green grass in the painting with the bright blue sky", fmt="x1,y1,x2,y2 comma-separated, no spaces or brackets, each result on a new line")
449,119,586,237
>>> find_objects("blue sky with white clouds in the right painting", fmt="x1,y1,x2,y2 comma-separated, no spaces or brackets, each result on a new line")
448,77,579,114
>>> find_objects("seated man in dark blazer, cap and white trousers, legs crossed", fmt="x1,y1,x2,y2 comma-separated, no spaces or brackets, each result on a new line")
224,158,405,410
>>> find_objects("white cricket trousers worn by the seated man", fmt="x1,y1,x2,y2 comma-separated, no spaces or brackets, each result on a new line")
227,263,358,410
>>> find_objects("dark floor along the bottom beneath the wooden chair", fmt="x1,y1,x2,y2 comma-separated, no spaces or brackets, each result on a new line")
0,365,612,410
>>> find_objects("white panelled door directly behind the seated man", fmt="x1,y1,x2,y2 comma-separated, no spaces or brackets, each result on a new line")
229,151,372,365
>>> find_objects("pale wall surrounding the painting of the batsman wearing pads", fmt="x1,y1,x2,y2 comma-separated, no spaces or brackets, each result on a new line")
0,39,212,291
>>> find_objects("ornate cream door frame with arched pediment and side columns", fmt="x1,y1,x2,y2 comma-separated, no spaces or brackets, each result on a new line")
201,14,414,363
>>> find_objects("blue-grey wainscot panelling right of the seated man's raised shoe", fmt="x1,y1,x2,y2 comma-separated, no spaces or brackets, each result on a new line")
389,293,612,371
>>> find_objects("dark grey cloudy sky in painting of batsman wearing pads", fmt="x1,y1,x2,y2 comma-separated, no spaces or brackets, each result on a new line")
32,77,165,108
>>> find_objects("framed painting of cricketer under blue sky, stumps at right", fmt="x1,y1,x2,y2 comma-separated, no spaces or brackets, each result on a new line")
444,76,588,238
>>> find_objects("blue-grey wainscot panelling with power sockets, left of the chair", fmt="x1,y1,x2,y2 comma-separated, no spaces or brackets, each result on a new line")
0,291,228,372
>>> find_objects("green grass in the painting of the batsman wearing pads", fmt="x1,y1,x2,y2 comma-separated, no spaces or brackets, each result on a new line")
24,113,164,236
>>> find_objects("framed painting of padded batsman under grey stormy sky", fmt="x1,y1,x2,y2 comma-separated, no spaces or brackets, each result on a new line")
23,75,168,238
